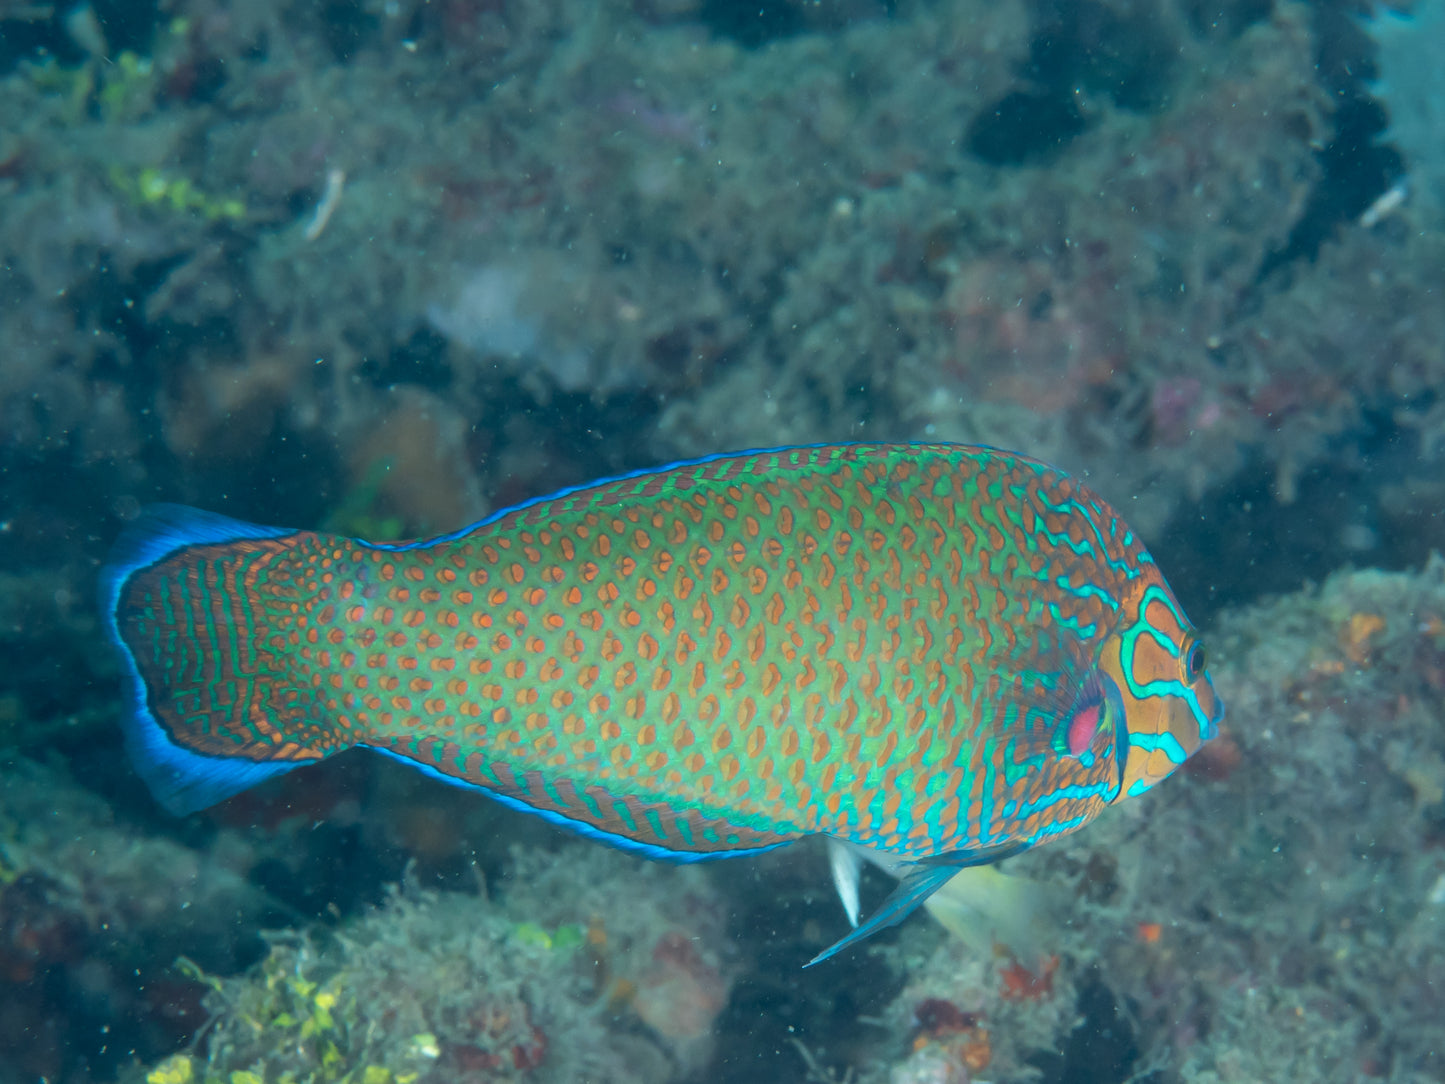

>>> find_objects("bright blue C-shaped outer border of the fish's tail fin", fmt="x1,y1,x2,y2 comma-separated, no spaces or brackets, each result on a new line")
100,504,306,817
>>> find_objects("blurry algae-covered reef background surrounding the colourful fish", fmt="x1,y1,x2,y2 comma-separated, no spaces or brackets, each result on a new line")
0,0,1445,1084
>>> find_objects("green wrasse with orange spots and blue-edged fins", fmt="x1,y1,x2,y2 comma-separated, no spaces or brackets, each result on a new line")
101,444,1224,963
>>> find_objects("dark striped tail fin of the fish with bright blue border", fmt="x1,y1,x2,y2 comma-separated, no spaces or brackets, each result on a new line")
100,504,332,814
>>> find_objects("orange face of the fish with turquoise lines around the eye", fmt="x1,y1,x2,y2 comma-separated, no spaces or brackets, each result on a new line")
1097,564,1224,801
